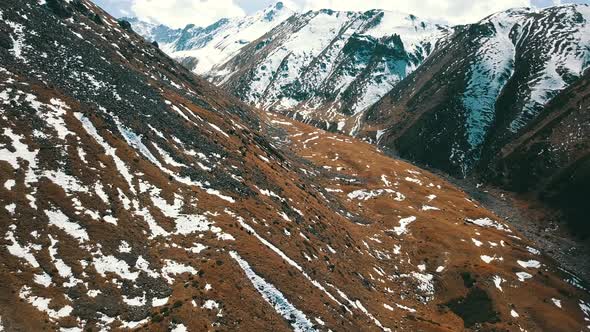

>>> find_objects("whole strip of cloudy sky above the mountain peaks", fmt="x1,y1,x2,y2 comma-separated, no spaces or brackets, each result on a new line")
93,0,590,28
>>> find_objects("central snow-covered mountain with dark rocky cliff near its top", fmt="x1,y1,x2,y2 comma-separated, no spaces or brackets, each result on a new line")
130,6,449,123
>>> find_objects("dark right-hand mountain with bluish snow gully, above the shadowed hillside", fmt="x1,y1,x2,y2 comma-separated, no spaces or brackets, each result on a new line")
364,5,590,177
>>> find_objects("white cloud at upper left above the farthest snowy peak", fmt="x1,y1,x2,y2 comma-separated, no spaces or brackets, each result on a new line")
131,0,246,28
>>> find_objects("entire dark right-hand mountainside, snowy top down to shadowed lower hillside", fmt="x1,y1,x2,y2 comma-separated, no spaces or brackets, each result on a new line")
361,5,590,236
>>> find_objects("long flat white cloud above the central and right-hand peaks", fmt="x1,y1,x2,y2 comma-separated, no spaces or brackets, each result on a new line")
296,0,532,24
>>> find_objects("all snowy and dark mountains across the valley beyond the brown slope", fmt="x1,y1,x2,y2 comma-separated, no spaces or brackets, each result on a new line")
133,3,590,249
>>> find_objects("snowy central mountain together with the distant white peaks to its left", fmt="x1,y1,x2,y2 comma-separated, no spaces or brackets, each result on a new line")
132,3,452,133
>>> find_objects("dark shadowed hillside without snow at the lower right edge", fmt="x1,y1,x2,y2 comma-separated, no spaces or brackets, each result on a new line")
490,72,590,237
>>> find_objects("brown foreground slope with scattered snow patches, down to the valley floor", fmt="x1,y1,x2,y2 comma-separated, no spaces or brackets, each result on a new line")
0,0,590,332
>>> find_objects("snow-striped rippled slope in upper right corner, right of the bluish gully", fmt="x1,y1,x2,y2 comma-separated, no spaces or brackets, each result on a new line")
484,5,590,153
